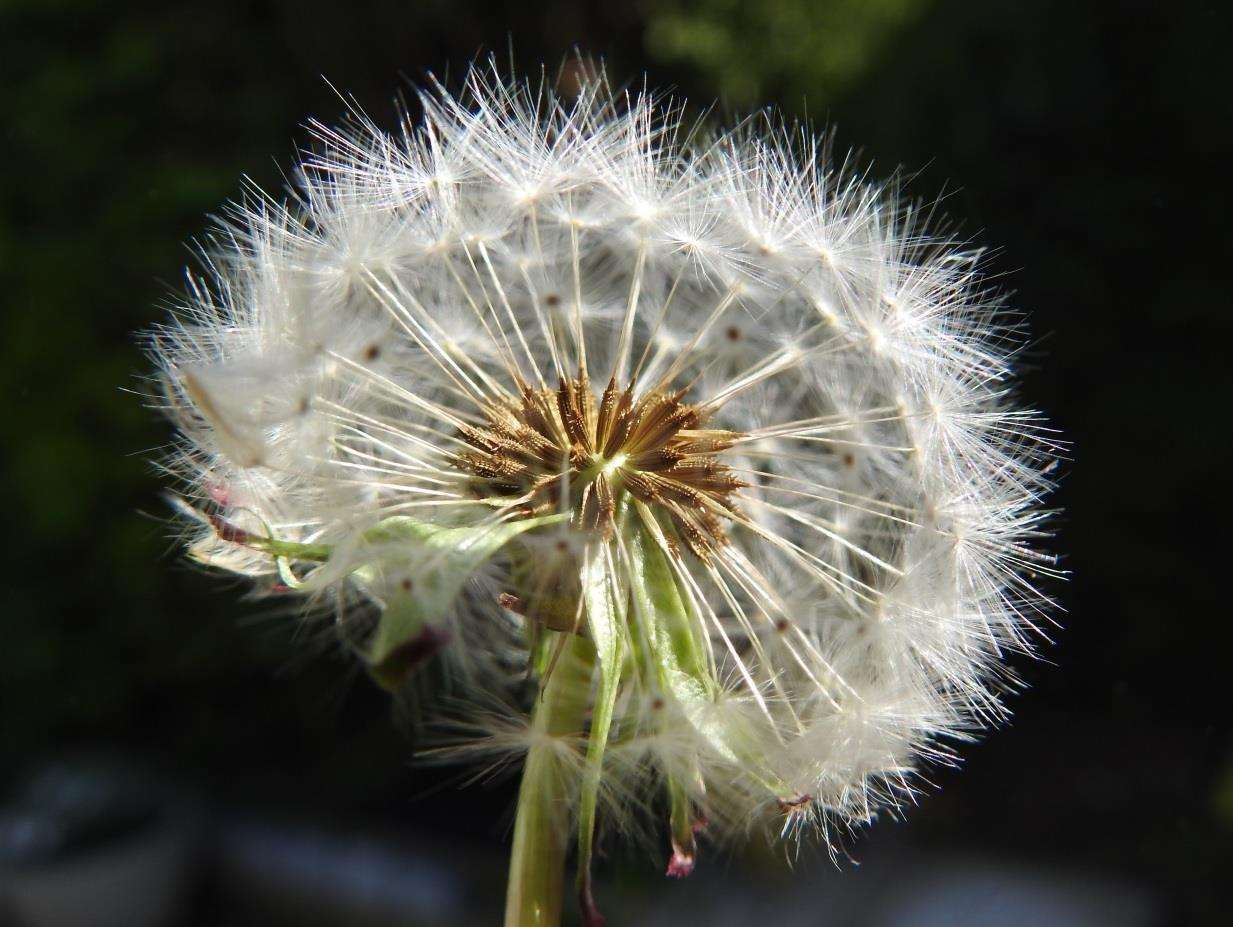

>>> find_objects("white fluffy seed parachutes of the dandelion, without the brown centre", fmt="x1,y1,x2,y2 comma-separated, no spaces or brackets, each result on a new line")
153,63,1057,877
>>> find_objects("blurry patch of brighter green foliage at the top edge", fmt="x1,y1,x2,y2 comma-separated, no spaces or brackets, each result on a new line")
646,0,933,107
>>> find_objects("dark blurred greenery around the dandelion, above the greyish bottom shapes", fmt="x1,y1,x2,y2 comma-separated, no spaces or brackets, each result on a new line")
0,0,1233,922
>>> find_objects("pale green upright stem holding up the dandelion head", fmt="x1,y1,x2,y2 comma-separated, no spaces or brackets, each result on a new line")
506,634,596,927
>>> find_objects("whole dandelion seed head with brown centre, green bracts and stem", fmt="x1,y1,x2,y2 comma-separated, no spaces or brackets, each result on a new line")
150,59,1058,925
